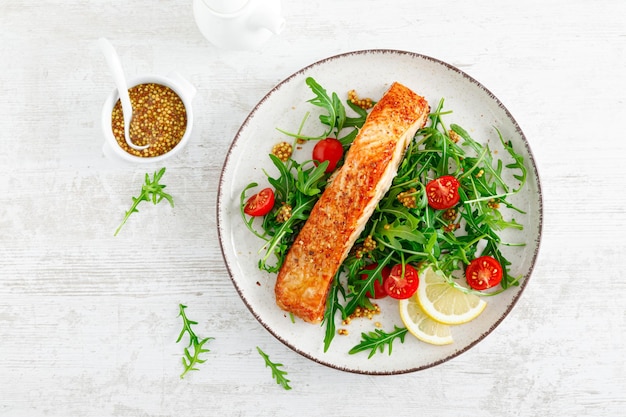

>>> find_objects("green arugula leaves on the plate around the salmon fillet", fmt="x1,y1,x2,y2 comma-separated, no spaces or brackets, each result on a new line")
241,77,527,357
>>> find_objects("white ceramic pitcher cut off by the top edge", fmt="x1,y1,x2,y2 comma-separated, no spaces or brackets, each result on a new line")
193,0,285,50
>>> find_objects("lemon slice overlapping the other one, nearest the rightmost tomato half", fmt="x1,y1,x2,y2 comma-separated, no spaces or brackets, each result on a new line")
415,266,487,324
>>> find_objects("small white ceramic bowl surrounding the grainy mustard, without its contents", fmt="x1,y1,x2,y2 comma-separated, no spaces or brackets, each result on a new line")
102,72,196,164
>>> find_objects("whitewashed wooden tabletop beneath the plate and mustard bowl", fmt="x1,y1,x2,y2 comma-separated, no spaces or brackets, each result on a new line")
0,0,626,416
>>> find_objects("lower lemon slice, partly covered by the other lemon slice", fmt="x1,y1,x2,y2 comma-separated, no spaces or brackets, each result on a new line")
398,295,453,345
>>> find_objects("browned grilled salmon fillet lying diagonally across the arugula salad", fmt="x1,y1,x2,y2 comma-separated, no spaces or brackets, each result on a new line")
275,83,430,323
